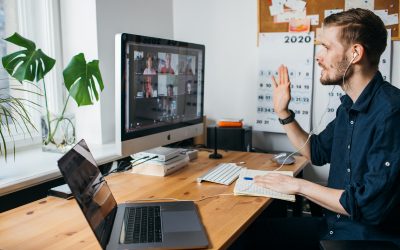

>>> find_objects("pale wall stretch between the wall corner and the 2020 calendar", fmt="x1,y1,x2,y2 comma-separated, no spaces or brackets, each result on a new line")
174,0,258,125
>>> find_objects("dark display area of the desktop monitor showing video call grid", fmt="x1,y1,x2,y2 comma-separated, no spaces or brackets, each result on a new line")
125,42,203,133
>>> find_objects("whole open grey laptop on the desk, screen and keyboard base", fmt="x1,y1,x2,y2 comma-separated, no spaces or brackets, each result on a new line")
58,140,208,249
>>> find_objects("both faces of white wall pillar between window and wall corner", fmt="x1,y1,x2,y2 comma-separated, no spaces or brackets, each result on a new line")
60,0,173,144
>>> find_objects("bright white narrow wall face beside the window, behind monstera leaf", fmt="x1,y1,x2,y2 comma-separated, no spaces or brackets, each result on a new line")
60,0,102,144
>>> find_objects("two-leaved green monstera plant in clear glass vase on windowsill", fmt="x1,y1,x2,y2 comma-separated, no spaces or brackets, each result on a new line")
0,33,104,155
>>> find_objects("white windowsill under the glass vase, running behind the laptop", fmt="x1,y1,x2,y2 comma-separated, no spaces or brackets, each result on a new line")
0,144,120,196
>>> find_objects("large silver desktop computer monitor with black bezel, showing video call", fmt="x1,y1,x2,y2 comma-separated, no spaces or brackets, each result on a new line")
115,33,205,156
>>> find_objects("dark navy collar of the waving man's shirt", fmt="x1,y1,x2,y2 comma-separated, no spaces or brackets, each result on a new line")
340,71,384,112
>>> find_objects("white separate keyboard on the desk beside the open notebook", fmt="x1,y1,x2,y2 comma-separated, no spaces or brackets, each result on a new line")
197,163,242,185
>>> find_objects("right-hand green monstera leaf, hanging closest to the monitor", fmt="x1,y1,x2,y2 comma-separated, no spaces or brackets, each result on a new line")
63,53,104,106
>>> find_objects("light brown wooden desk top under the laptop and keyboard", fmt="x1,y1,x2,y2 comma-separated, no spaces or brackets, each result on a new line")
0,151,308,249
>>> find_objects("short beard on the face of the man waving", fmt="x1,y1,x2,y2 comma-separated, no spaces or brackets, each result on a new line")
320,58,353,86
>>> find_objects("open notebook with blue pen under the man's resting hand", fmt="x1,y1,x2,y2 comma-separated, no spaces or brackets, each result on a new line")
233,168,296,202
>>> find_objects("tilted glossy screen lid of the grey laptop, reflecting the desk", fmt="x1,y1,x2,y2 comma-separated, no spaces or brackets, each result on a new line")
58,140,117,248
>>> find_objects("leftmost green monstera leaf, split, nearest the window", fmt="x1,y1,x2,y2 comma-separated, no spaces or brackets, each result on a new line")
2,33,56,82
